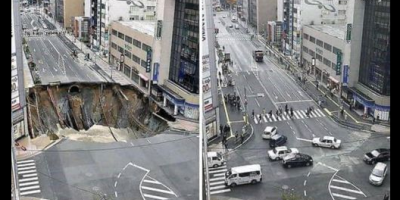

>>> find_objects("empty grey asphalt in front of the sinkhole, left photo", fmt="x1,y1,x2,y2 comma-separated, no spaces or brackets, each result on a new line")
25,133,199,200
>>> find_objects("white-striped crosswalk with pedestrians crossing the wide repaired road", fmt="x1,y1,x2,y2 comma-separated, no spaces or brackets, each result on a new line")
253,109,326,124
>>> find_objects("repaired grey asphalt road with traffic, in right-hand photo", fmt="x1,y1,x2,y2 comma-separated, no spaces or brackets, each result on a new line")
212,12,390,200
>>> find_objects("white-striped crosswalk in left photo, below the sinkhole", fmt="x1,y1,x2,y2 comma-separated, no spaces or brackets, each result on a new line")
17,160,40,196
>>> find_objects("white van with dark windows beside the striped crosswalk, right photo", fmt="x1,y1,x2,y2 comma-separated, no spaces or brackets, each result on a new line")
225,164,262,187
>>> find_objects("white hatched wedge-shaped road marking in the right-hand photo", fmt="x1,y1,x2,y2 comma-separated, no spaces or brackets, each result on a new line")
329,175,367,200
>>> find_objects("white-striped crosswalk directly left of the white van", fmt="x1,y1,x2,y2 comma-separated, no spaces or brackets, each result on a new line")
208,165,231,195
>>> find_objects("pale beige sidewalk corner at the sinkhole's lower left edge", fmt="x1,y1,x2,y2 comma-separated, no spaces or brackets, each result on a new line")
15,135,63,160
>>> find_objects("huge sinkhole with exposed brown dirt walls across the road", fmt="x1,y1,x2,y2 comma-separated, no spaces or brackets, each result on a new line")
27,84,168,142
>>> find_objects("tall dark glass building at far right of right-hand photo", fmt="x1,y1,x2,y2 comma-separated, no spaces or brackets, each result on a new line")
352,0,390,120
